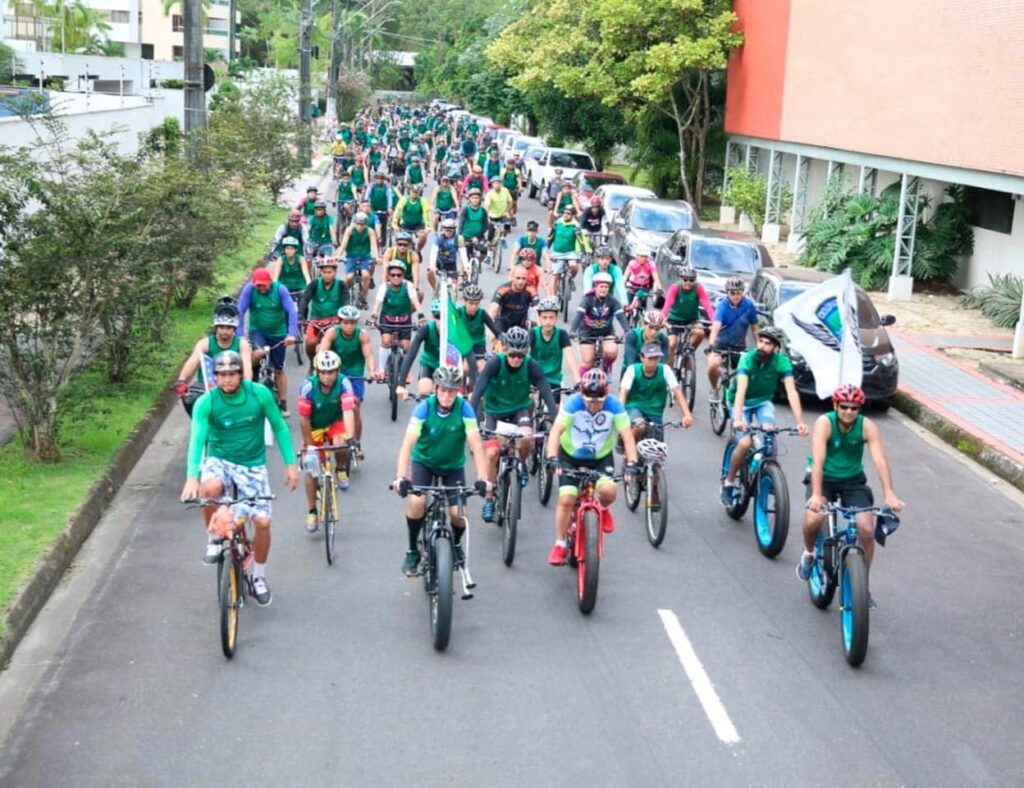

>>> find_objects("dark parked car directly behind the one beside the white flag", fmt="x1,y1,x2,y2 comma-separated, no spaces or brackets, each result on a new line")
654,227,775,303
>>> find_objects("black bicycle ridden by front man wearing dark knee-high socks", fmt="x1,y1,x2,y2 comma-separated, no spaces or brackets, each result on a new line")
401,480,476,651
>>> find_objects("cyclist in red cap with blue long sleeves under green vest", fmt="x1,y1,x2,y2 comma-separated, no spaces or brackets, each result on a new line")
239,268,299,418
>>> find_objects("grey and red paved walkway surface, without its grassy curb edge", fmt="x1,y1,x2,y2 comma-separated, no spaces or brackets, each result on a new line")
889,332,1024,464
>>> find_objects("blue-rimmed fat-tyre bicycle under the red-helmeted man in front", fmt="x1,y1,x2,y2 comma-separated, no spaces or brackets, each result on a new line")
807,499,899,667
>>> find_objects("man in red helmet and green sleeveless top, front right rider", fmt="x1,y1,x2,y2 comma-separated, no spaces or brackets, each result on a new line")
797,384,904,581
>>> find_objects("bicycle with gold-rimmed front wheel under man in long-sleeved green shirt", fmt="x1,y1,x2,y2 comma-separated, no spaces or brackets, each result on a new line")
185,495,274,659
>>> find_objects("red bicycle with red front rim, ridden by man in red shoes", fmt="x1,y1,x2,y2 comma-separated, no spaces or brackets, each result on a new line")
552,459,622,615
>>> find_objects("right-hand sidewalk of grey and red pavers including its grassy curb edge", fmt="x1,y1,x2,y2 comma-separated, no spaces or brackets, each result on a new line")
889,331,1024,489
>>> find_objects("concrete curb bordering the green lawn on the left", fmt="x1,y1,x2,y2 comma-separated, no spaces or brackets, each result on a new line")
0,389,178,667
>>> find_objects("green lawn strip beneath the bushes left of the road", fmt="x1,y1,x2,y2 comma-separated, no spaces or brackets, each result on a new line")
0,207,286,637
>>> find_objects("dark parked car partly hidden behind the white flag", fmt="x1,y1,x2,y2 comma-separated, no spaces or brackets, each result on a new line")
748,266,899,408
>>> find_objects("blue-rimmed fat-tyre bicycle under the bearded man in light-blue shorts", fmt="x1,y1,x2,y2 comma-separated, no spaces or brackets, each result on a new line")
721,425,799,558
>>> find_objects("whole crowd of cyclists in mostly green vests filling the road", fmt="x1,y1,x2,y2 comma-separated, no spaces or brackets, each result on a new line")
175,102,902,605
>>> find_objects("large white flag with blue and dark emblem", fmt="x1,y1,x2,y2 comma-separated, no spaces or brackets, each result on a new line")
775,269,864,399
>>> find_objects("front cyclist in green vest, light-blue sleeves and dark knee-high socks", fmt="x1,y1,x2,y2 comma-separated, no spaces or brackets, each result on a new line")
391,366,488,577
